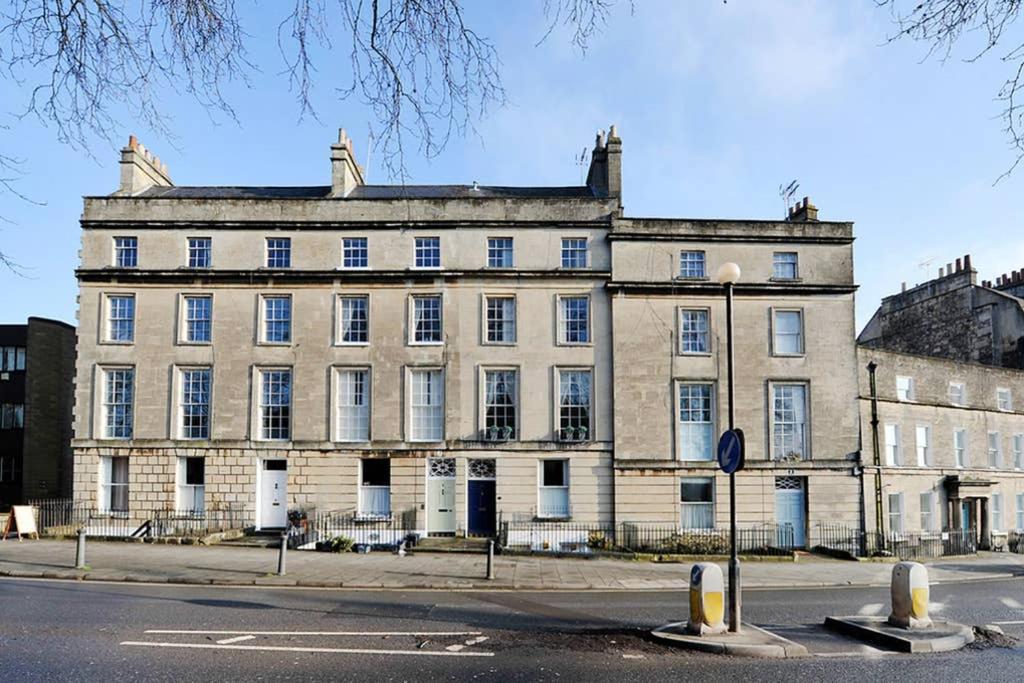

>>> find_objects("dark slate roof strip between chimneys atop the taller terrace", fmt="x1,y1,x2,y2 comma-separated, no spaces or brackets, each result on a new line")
138,185,596,200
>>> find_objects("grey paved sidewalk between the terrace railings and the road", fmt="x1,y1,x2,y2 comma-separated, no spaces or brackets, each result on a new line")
0,540,1024,590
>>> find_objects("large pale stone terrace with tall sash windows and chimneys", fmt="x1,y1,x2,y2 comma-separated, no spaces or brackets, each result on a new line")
74,128,860,536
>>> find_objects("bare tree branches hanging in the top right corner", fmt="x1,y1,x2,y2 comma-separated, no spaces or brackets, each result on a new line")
876,0,1024,182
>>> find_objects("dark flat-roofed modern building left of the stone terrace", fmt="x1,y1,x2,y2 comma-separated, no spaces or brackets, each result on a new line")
0,317,75,510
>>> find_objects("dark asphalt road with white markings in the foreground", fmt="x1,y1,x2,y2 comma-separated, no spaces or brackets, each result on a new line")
0,579,1024,682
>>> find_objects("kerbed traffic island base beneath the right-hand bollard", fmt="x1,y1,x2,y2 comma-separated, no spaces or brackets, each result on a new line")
825,616,974,653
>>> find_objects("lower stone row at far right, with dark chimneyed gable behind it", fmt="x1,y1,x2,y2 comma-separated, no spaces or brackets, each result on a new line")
857,264,1024,547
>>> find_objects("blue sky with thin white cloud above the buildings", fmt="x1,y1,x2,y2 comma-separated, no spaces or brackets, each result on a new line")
0,0,1024,326
